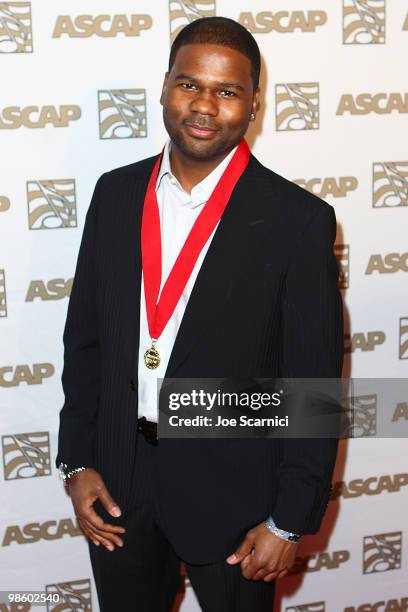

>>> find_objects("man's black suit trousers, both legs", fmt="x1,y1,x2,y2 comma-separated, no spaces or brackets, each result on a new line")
89,434,275,612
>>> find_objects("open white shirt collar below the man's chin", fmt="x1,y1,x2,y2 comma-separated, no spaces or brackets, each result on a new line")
155,140,237,208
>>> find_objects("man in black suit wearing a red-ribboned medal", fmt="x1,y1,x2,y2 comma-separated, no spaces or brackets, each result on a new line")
57,17,343,612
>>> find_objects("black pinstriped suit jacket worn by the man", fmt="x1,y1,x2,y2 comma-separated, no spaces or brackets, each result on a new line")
56,155,343,563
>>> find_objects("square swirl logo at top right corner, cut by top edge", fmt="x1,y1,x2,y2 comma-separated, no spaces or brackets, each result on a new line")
343,0,385,45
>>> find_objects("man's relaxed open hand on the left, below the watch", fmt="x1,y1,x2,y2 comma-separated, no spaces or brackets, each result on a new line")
68,468,125,551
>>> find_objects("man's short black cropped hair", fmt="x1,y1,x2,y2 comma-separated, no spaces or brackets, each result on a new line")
168,17,261,89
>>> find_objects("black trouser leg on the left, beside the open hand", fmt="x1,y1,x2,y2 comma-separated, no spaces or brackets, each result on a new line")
89,435,181,612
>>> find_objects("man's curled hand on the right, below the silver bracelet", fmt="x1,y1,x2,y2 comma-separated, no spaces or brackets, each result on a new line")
226,523,298,582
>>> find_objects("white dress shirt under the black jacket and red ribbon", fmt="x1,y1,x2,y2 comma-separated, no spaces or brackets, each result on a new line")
138,141,237,422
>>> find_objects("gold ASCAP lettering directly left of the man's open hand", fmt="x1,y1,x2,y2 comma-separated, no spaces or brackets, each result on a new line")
1,518,82,546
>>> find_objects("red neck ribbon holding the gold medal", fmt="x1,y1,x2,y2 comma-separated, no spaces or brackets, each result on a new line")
142,139,250,339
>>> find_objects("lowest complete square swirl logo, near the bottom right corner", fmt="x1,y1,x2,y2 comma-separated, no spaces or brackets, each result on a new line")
363,531,402,574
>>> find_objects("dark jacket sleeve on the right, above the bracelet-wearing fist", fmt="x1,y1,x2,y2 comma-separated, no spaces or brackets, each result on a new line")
272,205,343,534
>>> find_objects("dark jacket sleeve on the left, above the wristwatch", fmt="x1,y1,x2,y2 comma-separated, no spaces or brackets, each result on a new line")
56,176,103,468
